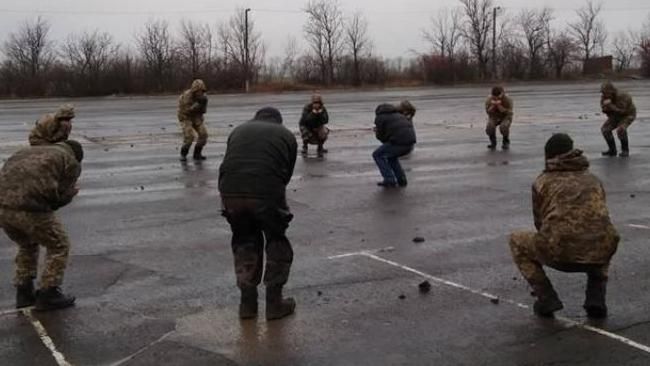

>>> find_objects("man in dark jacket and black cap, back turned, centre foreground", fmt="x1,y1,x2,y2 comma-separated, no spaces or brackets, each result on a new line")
219,107,298,320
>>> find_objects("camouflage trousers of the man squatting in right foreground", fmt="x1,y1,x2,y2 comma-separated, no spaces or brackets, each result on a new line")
510,231,609,288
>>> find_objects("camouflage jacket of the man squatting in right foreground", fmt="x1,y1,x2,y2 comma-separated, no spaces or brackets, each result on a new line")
533,150,619,264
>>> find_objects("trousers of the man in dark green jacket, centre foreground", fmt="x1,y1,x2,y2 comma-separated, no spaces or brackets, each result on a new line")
222,197,293,289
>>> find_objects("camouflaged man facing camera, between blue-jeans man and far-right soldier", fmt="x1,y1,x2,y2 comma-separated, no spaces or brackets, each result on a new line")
485,86,513,150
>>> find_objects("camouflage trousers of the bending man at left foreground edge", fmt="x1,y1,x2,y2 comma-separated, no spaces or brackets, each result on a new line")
0,209,70,288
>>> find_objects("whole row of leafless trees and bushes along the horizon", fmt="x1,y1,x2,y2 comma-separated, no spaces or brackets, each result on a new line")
0,0,650,96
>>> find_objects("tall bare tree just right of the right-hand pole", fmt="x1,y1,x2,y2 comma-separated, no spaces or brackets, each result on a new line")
517,8,553,78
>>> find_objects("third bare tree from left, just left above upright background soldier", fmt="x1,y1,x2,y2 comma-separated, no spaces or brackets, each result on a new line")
136,20,174,91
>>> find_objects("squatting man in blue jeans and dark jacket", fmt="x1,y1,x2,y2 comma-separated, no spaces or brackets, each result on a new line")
372,104,416,188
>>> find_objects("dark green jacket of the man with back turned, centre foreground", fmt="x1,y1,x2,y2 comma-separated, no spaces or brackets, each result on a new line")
219,120,298,200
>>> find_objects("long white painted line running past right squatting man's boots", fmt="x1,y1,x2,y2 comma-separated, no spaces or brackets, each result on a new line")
328,251,650,353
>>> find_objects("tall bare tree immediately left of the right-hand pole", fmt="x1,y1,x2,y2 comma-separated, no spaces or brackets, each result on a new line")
460,0,494,78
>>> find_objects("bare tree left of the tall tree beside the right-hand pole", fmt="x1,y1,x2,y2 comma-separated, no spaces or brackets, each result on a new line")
422,8,463,63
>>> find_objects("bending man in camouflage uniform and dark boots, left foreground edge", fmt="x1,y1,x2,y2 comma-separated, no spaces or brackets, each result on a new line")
0,140,83,310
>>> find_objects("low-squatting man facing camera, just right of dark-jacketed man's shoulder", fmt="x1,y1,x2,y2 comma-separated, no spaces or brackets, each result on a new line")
299,94,329,157
